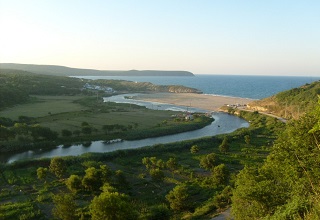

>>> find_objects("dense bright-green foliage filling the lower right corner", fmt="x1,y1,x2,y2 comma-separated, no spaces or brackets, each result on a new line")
232,100,320,219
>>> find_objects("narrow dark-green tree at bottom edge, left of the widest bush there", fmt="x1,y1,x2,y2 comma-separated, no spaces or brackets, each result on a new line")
52,193,78,220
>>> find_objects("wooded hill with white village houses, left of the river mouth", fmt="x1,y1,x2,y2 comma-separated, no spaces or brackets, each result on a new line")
0,69,201,109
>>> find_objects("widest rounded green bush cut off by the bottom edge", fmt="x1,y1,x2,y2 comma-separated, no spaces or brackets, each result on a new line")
89,192,138,220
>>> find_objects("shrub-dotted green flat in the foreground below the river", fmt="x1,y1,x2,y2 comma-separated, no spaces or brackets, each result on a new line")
0,108,284,219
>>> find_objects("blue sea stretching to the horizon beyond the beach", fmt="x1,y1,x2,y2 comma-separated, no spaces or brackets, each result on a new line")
76,74,320,99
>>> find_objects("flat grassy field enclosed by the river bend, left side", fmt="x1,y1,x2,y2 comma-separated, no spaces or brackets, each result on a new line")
0,96,172,131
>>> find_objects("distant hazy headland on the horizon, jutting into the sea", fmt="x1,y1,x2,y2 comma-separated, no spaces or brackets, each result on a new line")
0,63,194,76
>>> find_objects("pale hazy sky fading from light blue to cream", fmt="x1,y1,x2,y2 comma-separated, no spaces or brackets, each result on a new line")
0,0,320,76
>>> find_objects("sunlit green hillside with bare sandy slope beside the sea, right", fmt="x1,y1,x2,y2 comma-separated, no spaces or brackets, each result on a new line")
248,81,320,119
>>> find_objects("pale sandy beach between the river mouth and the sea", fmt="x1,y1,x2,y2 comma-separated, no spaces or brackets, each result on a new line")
133,93,253,111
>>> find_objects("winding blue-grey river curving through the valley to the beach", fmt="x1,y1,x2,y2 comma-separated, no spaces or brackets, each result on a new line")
0,94,249,163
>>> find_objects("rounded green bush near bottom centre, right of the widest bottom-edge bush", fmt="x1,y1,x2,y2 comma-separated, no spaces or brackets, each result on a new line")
166,185,190,211
